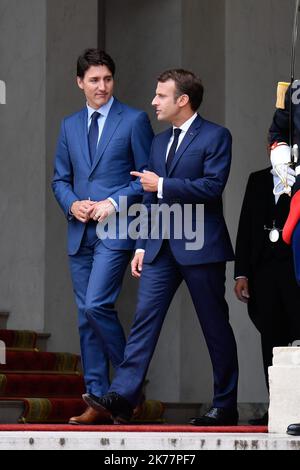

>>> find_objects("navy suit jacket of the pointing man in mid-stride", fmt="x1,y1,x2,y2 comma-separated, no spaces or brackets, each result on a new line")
136,115,234,265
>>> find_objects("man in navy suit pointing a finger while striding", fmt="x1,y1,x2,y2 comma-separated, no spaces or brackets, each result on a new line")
83,70,238,426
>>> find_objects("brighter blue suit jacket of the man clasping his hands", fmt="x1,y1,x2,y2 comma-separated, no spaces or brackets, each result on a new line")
52,98,153,255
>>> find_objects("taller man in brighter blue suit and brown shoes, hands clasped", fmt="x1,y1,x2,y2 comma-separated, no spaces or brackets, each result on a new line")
52,49,153,424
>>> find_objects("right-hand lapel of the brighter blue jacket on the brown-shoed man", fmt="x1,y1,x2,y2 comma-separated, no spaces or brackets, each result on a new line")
91,98,122,173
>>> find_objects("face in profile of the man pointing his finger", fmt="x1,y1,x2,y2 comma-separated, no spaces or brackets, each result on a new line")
152,80,181,122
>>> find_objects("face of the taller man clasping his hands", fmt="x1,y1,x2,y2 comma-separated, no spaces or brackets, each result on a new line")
77,65,114,109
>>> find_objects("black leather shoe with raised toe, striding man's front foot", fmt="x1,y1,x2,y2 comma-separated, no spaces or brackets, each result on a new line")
82,392,133,423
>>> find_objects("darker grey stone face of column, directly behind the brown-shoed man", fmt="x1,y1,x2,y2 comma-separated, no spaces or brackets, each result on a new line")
44,0,98,351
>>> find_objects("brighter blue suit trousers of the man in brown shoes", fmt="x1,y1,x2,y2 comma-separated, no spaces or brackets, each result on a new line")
69,222,131,396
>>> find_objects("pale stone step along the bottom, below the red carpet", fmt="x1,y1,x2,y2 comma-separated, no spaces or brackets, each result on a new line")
0,425,300,452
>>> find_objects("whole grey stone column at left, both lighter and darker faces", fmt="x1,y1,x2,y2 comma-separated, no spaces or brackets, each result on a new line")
0,0,98,351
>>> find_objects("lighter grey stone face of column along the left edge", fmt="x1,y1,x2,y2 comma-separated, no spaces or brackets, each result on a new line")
0,0,46,330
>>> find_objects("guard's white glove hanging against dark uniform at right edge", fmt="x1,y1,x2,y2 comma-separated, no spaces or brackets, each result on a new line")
270,142,296,195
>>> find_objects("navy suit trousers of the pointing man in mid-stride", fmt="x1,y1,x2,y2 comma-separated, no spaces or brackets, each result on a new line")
109,241,238,408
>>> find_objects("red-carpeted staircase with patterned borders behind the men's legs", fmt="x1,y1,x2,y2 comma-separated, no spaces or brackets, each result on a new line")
0,312,164,424
